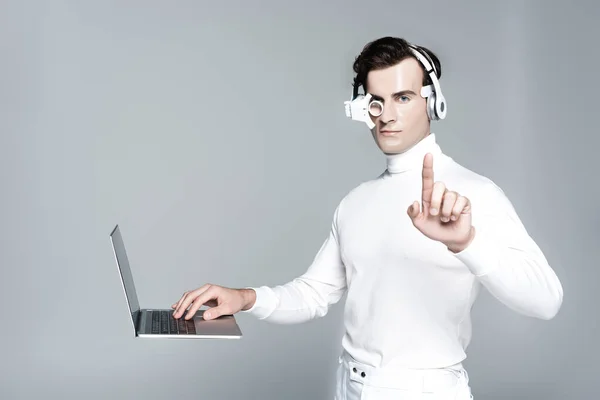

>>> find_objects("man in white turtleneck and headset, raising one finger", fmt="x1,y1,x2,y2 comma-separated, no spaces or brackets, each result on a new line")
172,37,563,400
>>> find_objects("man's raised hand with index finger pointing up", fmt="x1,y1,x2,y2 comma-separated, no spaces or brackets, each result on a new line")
407,154,475,253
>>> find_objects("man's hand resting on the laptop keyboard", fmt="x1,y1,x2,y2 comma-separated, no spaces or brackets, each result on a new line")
171,284,256,320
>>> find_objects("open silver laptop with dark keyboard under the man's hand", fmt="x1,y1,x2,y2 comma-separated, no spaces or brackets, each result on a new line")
110,224,242,339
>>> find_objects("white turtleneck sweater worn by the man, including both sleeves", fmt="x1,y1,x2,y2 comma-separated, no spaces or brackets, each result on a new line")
239,133,563,368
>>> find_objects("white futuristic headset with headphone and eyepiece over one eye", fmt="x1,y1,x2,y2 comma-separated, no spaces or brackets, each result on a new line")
344,44,448,129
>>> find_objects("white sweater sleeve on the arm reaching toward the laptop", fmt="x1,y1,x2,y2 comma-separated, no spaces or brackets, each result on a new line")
242,202,346,324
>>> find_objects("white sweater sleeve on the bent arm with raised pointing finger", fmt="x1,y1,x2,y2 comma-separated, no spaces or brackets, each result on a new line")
453,183,563,320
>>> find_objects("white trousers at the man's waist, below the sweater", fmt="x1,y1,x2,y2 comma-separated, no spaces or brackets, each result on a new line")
335,352,473,400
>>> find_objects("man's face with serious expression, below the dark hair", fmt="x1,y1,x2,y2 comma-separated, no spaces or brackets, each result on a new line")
366,57,429,154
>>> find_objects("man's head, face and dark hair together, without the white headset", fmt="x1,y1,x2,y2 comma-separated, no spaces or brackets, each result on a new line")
354,37,442,154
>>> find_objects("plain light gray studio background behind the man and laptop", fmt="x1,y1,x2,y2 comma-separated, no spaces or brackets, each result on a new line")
0,0,600,399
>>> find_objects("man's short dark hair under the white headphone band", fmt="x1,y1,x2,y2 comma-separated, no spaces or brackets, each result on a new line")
353,36,442,95
